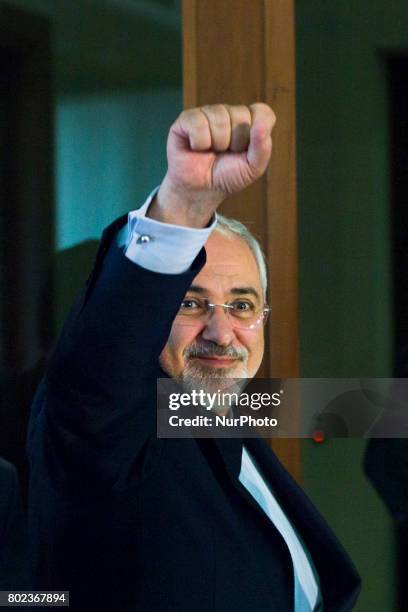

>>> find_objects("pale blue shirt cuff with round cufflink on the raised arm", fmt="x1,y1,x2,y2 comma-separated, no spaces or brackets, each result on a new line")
118,187,217,274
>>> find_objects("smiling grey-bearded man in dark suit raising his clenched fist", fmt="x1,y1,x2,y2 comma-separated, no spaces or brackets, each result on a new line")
29,104,359,612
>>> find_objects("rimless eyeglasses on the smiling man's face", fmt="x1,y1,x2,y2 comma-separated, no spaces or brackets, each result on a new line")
174,297,271,329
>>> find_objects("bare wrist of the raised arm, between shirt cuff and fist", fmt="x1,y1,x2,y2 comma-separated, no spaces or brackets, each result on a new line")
146,175,224,229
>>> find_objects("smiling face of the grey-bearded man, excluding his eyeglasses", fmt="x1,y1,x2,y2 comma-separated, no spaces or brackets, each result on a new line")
160,231,264,380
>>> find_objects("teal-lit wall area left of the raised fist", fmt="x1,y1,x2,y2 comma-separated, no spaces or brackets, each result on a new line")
56,88,182,250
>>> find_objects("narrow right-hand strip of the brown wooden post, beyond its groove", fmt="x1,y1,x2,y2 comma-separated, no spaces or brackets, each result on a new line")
265,0,299,377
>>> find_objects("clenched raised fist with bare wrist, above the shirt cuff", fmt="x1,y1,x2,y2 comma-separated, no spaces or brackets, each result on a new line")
148,103,275,227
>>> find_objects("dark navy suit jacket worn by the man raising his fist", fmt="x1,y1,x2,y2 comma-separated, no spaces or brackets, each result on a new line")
28,219,359,612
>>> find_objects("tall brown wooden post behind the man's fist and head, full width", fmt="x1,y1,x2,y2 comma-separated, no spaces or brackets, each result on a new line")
183,0,300,479
